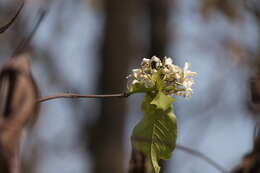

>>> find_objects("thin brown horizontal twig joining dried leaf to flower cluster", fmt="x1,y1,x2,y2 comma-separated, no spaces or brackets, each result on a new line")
38,93,129,103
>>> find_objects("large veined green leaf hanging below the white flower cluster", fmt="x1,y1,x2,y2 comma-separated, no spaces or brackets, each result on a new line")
132,93,177,173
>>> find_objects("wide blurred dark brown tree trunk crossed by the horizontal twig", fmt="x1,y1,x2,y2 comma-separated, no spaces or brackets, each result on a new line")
89,0,134,173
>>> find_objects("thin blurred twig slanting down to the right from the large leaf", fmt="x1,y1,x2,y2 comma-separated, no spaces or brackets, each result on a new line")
176,144,228,173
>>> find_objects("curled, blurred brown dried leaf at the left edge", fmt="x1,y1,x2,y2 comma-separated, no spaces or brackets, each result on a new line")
0,55,38,173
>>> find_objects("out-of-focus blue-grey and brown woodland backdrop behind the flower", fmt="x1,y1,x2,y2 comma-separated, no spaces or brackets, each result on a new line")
0,0,260,173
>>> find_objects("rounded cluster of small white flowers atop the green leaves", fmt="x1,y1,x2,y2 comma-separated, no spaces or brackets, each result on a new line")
128,56,196,97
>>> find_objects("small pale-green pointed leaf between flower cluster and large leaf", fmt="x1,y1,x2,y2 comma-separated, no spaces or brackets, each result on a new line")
151,91,175,111
